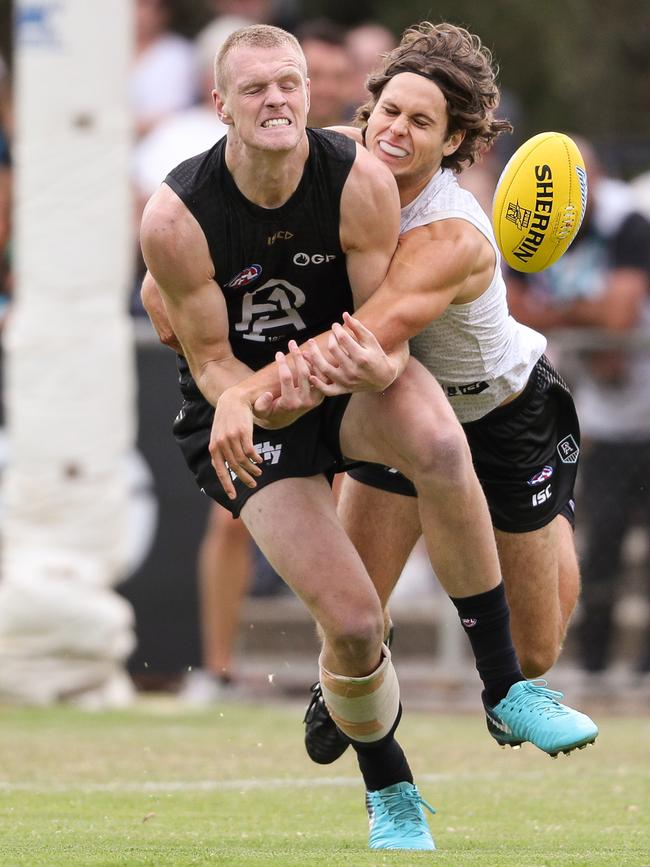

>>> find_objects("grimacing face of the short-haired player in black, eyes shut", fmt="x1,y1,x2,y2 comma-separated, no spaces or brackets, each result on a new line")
214,45,309,151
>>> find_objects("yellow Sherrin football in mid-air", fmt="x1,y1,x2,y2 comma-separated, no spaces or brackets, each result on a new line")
492,132,587,273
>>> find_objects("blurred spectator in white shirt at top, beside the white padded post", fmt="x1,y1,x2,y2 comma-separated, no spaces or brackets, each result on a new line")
131,0,199,137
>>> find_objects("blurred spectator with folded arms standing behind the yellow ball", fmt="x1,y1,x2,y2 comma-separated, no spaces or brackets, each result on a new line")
508,140,650,673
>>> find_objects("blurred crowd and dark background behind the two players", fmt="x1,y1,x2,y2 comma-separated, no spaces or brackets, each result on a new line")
0,0,650,701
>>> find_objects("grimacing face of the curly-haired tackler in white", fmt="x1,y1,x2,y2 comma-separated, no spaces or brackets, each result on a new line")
366,72,463,192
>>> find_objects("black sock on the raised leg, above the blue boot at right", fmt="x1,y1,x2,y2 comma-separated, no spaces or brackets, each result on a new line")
449,581,525,707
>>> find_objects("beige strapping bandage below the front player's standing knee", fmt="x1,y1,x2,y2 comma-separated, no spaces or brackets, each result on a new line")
319,645,399,743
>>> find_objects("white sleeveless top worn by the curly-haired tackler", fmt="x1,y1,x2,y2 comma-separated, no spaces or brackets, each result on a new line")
400,169,546,423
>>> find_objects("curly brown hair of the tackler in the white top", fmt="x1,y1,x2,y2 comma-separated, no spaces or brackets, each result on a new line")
355,21,512,172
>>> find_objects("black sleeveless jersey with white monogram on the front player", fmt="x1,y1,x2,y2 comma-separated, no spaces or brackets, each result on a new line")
165,129,356,395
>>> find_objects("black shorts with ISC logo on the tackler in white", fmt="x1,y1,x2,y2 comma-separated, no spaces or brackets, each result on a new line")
348,356,580,533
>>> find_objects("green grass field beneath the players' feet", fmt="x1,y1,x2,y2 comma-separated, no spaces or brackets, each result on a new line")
0,699,650,867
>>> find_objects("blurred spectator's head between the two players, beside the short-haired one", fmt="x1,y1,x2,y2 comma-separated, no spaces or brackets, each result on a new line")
295,18,352,127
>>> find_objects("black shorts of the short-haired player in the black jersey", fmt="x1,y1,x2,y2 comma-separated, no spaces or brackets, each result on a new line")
173,395,350,518
